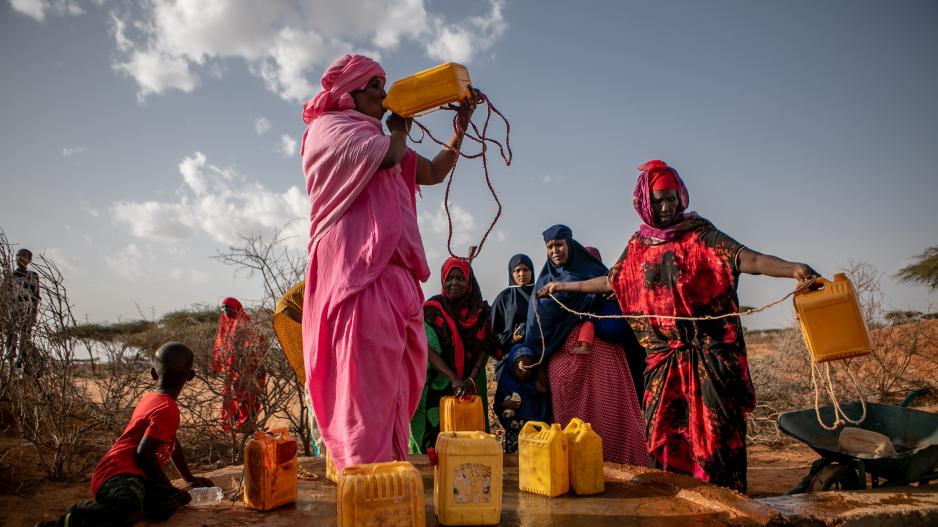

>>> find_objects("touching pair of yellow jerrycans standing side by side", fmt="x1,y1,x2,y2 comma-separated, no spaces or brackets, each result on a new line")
518,418,606,498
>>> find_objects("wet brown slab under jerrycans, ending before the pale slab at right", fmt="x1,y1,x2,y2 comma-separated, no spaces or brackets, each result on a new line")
154,456,772,527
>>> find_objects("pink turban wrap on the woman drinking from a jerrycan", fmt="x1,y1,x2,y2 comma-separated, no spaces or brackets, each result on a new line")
303,55,385,124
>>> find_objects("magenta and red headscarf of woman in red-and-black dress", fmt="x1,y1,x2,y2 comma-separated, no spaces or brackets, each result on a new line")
632,159,698,241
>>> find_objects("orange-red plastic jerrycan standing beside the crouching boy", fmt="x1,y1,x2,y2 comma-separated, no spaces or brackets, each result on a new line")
244,428,296,511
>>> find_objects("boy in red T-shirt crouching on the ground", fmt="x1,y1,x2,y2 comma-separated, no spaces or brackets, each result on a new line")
37,342,213,527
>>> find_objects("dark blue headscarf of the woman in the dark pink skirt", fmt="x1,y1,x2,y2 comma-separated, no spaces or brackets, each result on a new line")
524,225,609,359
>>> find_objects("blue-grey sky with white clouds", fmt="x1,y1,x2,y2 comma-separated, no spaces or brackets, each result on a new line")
0,0,938,328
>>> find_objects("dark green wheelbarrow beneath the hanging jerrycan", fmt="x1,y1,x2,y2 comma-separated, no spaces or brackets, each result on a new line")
778,388,938,494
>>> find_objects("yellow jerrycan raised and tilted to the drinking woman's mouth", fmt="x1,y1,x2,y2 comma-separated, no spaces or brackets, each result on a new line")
383,62,472,117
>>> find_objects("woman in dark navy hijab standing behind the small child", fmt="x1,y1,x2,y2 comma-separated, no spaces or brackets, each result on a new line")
491,254,534,354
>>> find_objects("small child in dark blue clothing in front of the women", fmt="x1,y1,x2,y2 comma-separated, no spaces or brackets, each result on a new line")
494,344,550,453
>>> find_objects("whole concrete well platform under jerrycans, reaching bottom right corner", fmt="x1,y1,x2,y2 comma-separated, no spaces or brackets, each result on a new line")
154,455,938,527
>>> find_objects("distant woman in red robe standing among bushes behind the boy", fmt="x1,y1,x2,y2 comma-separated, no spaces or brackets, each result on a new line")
212,297,267,431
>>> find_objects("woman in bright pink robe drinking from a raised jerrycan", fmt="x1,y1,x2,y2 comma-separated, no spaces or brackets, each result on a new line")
302,55,475,471
